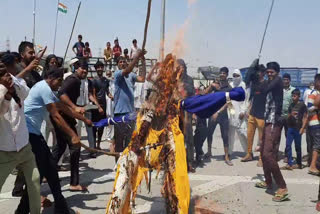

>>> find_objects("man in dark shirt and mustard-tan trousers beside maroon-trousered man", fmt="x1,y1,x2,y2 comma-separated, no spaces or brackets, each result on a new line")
241,65,267,162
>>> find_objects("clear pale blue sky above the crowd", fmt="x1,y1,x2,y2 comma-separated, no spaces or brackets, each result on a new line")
0,0,320,74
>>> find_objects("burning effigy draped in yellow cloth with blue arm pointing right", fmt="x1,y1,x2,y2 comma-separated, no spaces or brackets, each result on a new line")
106,54,244,214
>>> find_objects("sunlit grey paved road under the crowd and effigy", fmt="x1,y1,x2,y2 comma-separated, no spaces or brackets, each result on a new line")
0,126,319,214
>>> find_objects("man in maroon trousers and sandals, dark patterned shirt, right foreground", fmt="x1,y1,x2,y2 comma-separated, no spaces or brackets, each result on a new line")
256,62,288,202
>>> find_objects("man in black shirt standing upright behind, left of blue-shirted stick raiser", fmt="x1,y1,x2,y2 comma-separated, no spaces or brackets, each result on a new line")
92,61,113,149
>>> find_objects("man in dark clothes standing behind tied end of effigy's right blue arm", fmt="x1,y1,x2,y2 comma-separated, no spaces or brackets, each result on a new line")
206,67,233,166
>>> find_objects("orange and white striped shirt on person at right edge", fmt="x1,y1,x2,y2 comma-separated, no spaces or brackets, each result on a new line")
308,90,320,128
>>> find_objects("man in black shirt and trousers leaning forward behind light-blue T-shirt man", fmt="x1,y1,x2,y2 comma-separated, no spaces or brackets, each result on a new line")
52,60,92,191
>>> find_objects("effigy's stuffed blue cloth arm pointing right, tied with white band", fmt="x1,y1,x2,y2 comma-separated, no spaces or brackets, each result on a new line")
181,87,245,118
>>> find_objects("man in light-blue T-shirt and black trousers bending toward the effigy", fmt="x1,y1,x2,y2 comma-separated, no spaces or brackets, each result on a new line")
17,69,89,214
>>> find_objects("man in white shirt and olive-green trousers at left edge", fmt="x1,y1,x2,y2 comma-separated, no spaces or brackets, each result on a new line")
0,63,41,214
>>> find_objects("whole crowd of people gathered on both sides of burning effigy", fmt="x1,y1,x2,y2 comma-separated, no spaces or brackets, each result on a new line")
0,35,320,214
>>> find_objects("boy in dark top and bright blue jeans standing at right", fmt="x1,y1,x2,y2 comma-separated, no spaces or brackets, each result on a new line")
281,89,307,170
